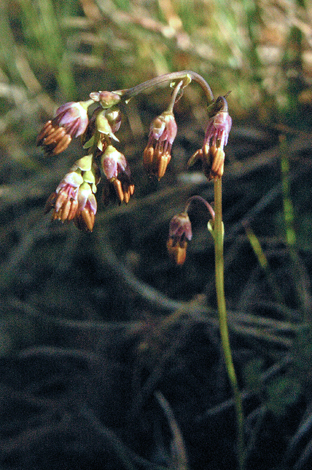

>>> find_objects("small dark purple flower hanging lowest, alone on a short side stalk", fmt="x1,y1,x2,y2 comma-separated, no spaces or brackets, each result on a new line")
167,212,192,266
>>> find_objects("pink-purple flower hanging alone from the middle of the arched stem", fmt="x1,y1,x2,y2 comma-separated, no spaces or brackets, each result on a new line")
143,111,177,180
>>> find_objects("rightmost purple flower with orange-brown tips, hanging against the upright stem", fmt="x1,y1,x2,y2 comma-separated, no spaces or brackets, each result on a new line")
188,96,232,180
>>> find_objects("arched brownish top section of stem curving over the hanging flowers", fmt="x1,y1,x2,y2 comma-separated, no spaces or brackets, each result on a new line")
122,70,214,104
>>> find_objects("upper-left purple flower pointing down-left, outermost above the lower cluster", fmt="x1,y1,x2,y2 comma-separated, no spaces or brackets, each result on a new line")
37,101,90,155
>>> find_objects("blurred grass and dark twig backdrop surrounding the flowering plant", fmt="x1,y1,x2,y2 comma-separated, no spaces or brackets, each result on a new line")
0,0,312,470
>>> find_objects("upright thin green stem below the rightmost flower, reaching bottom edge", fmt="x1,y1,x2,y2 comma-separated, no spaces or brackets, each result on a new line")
214,178,245,470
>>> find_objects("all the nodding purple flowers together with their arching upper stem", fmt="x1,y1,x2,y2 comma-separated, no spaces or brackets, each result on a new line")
37,71,232,264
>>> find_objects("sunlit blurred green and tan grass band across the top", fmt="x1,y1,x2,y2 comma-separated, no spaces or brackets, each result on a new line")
0,0,312,120
